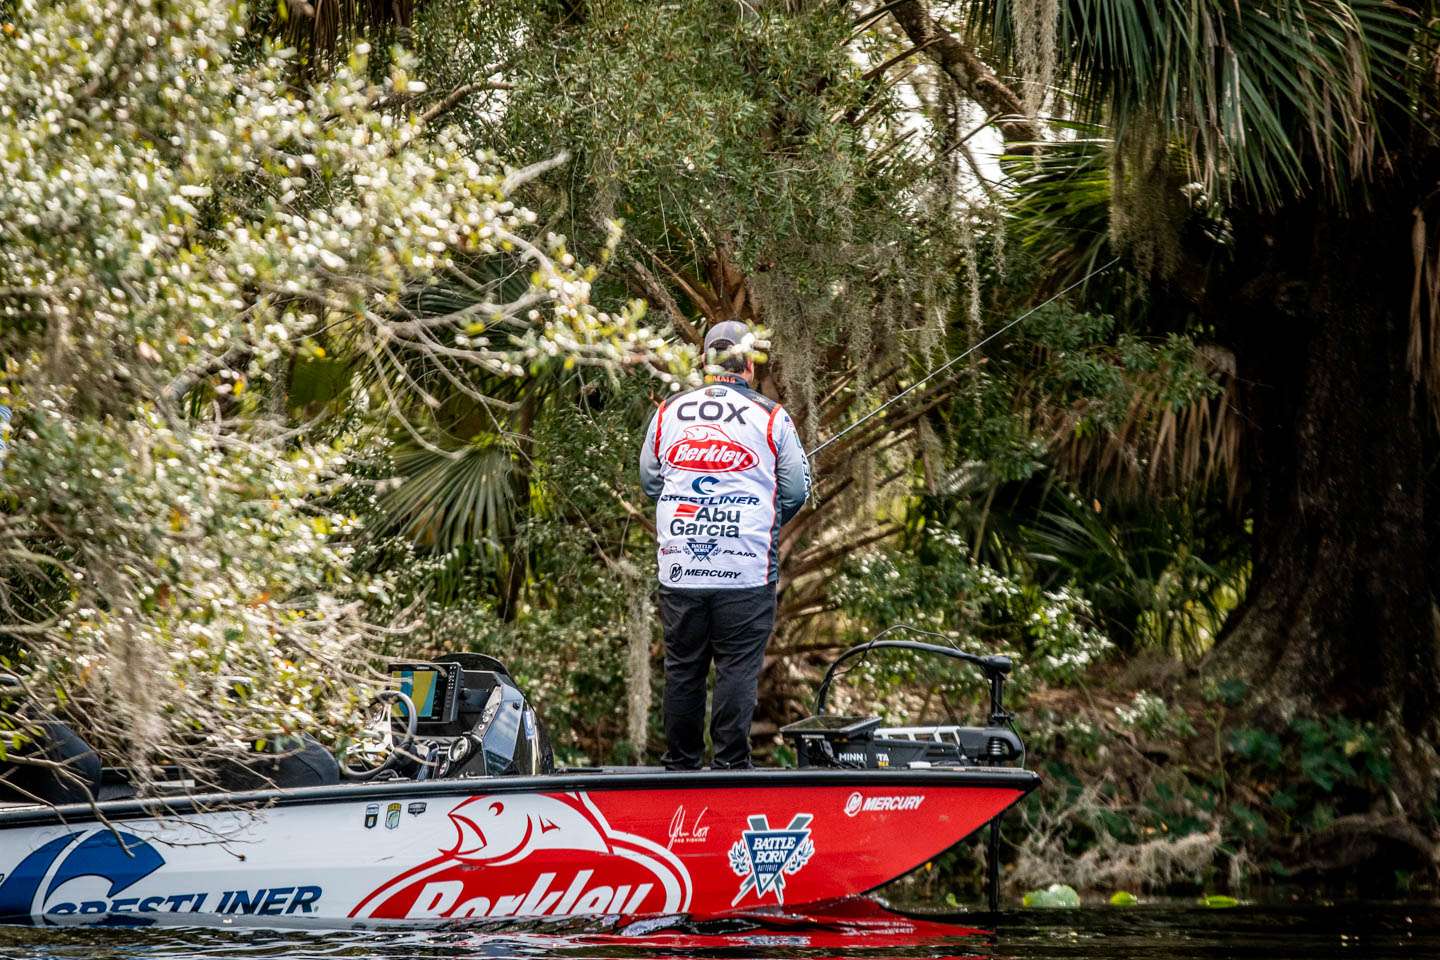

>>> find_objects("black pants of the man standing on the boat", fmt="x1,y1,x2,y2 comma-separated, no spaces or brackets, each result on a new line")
660,584,775,770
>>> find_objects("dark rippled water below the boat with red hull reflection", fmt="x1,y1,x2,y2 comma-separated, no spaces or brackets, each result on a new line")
0,904,1440,960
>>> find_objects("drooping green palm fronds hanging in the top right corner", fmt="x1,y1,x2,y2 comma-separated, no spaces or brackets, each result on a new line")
969,0,1423,206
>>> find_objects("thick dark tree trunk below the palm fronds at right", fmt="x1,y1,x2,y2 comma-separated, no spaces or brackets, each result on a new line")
1210,197,1440,737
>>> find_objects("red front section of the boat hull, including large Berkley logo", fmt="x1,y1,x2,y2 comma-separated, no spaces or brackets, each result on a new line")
350,777,1025,920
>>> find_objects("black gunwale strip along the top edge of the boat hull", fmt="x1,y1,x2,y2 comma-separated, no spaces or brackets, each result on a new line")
0,767,1040,830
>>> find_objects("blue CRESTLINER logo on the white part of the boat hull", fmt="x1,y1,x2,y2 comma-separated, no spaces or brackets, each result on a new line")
0,828,323,924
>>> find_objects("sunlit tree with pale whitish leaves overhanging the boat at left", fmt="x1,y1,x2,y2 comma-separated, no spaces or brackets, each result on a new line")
0,0,693,794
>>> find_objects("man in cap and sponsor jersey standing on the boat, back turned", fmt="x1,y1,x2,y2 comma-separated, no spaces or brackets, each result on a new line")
639,320,811,770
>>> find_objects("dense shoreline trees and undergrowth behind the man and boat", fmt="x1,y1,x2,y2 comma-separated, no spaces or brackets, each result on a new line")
0,0,1440,905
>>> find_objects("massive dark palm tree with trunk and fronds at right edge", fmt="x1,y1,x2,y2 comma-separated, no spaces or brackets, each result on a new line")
965,0,1440,743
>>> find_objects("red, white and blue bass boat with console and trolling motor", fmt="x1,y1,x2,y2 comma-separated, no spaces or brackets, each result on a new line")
0,639,1038,925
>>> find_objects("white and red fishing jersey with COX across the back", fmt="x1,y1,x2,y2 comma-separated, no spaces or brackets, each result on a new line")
639,377,809,590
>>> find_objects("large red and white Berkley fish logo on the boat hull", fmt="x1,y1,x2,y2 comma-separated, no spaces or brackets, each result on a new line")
350,793,691,920
